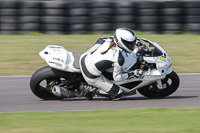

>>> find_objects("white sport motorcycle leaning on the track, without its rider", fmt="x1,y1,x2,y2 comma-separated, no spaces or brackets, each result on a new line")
30,38,180,100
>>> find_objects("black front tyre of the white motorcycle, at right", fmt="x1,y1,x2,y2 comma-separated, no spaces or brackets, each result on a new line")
138,71,180,98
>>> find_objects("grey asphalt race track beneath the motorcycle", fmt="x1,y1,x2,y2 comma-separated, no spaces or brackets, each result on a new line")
0,74,200,113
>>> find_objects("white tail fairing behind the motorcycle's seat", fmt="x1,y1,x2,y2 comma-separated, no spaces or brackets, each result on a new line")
39,45,80,72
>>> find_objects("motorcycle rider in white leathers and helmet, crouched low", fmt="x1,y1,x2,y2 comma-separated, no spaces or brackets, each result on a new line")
80,28,141,100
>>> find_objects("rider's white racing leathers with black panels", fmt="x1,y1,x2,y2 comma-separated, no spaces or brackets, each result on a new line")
80,38,128,97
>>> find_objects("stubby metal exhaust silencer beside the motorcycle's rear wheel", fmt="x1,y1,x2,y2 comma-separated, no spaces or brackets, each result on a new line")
52,85,77,98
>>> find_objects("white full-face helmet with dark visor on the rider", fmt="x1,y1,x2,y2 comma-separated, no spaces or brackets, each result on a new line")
114,28,136,53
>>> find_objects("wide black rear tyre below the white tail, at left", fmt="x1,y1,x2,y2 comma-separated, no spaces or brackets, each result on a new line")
30,66,63,100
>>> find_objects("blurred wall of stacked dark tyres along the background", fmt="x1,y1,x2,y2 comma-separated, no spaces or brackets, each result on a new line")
0,1,200,34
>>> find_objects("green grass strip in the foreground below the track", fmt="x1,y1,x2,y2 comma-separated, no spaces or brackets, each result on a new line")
0,109,200,133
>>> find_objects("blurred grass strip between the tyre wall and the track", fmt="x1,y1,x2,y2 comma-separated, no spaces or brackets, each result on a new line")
0,32,200,76
